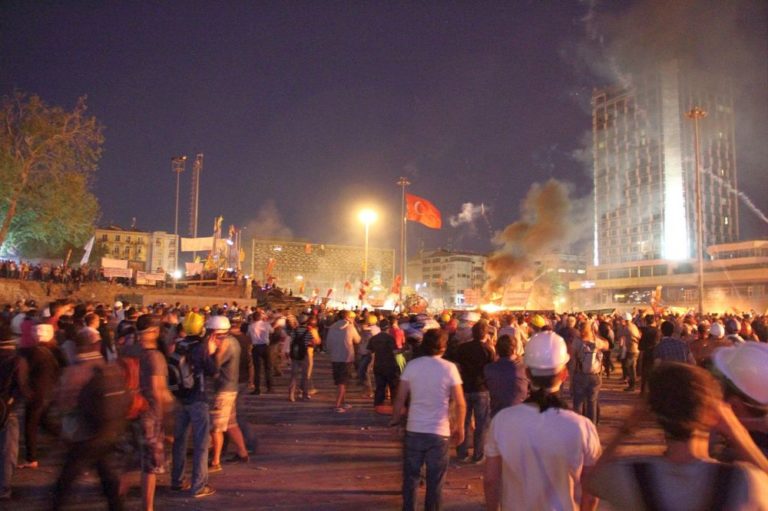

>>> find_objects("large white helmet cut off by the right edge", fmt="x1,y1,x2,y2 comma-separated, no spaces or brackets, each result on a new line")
712,342,768,406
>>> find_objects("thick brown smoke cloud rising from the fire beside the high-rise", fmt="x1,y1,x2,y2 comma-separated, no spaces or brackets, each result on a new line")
484,179,591,293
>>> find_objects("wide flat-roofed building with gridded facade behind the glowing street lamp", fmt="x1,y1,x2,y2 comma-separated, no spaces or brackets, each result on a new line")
245,239,395,301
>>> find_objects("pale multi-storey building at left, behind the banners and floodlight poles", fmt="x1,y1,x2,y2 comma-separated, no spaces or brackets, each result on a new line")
94,225,178,272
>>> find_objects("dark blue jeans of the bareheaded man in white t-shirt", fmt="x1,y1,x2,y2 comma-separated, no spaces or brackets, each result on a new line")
403,431,448,511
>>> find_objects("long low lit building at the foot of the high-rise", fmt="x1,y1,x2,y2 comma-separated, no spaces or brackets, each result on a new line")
568,240,768,313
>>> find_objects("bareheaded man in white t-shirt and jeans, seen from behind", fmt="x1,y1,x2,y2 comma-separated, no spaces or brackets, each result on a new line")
390,329,466,511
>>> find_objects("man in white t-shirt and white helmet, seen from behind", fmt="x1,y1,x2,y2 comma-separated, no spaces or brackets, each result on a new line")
484,332,601,511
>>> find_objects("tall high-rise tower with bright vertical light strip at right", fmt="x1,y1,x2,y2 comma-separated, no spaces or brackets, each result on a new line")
592,62,739,266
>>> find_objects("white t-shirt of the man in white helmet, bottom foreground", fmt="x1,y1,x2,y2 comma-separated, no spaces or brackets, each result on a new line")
485,404,601,510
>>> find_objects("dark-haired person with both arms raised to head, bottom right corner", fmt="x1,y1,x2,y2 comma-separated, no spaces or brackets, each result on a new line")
586,362,768,511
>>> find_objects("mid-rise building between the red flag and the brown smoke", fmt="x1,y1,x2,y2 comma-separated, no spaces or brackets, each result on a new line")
407,249,487,307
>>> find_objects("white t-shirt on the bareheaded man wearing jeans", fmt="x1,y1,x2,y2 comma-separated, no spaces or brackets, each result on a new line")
400,356,462,436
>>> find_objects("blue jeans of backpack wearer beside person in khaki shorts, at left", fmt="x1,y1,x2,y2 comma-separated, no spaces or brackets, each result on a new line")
171,401,211,493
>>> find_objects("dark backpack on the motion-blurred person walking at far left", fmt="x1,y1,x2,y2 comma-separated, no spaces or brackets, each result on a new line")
77,364,132,437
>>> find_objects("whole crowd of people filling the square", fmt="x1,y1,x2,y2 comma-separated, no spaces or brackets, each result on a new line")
0,300,768,510
